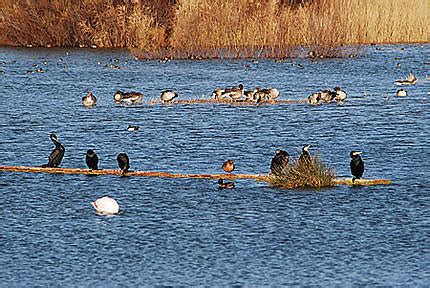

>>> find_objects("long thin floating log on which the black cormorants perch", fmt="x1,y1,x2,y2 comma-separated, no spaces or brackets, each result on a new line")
0,166,392,186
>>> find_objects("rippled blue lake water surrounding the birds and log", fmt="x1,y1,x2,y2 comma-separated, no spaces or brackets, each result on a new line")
0,44,430,287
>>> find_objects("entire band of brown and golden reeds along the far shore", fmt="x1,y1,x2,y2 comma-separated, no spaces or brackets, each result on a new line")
0,0,430,58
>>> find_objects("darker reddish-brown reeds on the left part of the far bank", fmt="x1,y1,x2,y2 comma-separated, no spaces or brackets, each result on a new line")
0,0,160,49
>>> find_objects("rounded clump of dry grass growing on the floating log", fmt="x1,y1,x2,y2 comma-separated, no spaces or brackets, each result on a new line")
267,156,335,189
